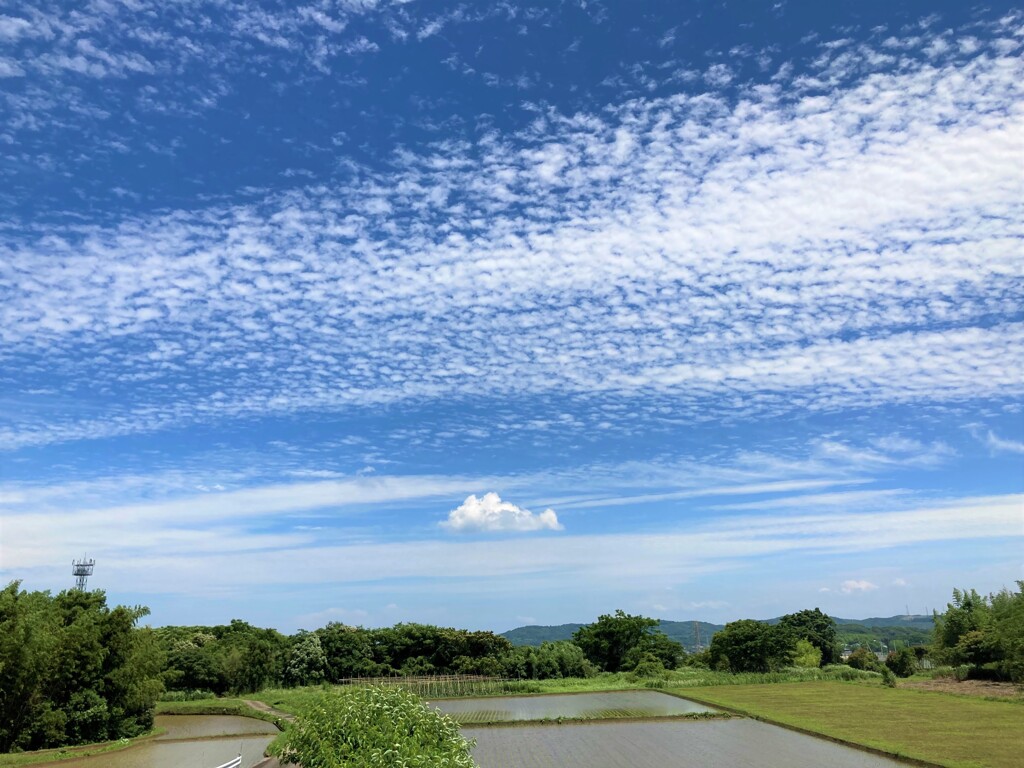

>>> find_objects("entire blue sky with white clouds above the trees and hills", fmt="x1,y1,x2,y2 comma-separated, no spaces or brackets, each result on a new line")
0,0,1024,632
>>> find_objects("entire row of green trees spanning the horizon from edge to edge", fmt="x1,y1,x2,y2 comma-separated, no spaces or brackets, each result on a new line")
0,582,1024,752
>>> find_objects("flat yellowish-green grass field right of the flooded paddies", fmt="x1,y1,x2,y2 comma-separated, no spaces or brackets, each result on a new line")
670,682,1024,768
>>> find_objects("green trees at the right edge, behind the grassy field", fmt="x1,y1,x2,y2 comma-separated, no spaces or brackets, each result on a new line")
932,582,1024,682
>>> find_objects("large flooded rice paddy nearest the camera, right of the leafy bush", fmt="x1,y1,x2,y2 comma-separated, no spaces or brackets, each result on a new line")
462,719,903,768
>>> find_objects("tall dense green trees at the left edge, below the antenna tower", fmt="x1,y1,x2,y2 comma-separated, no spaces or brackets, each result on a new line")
0,582,163,752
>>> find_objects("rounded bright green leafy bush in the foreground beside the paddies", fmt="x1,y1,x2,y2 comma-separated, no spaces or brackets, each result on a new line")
270,686,476,768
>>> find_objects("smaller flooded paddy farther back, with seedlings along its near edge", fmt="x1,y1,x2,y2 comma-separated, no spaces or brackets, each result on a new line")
430,690,715,724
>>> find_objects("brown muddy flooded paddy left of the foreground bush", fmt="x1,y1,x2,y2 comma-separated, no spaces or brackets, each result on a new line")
42,715,278,768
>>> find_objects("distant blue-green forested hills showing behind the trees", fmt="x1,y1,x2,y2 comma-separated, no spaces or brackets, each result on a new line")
501,614,933,651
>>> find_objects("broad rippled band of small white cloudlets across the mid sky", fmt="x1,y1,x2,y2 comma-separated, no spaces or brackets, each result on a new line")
0,18,1024,450
